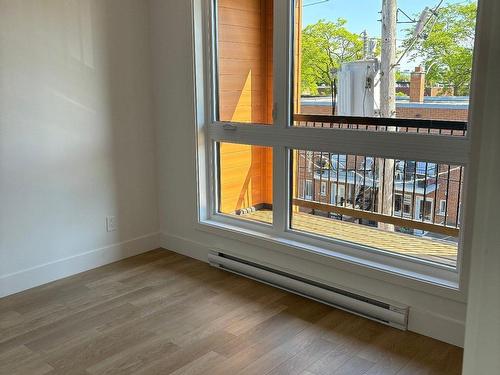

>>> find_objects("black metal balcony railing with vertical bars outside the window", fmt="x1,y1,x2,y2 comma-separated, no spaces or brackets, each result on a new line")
292,115,467,238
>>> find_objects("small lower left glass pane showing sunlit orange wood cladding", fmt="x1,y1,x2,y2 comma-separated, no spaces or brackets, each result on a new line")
218,142,273,223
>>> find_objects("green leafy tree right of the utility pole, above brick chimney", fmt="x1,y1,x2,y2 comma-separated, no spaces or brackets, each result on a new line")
404,1,477,95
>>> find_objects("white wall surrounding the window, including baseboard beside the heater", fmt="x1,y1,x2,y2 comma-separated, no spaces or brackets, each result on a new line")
151,0,466,345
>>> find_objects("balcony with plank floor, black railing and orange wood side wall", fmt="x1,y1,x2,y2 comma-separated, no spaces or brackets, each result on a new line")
219,115,466,267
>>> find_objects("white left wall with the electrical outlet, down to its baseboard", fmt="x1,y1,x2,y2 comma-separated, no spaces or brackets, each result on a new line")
0,0,158,296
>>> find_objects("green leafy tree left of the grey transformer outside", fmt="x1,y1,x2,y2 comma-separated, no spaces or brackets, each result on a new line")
301,18,363,104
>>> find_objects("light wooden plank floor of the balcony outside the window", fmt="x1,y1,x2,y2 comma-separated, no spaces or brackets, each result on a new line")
241,210,457,266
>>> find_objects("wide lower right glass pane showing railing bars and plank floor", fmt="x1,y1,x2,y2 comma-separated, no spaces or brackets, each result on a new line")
291,150,464,266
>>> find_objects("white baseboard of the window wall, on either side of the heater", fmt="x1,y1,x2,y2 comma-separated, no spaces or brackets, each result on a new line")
160,233,465,347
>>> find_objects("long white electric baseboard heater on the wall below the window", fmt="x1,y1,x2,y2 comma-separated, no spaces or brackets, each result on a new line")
208,251,408,330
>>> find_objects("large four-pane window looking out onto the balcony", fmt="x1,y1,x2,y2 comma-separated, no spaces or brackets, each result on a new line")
201,0,476,284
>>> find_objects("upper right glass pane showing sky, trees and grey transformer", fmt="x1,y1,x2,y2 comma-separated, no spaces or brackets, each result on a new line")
293,0,477,132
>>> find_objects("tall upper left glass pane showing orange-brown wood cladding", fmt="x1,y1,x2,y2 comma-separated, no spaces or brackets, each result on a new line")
216,0,273,124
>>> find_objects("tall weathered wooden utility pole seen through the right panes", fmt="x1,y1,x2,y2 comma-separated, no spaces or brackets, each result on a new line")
378,0,396,231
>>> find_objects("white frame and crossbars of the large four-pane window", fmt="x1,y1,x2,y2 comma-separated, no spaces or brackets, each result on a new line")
193,0,471,290
